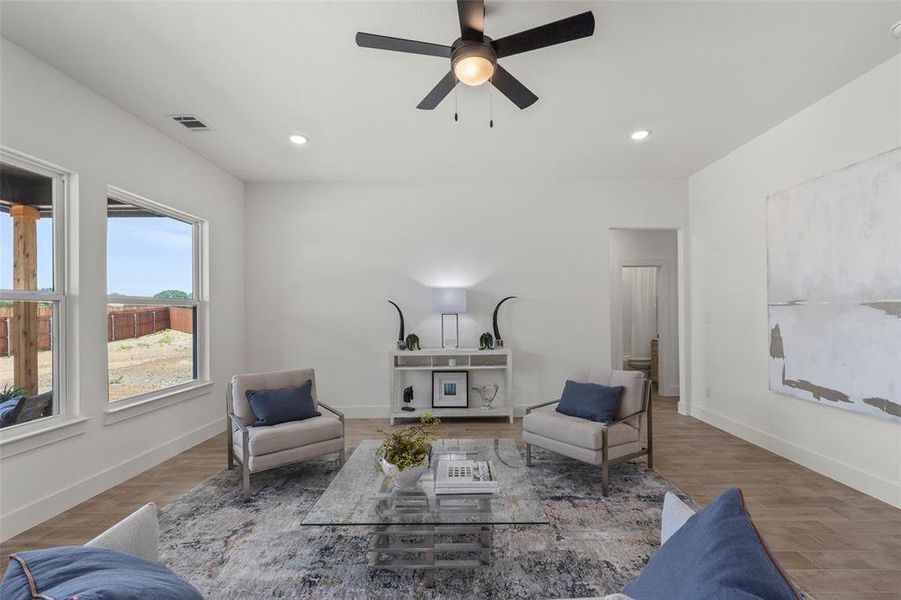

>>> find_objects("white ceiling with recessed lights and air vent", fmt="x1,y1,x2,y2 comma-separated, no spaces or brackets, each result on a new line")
2,0,901,181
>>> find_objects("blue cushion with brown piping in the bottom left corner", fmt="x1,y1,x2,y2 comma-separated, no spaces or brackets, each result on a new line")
0,546,203,600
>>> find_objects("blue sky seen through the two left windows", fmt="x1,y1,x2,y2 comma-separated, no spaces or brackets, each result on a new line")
0,213,193,296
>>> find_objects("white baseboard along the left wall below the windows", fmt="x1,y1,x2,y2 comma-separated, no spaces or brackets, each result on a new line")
0,418,225,541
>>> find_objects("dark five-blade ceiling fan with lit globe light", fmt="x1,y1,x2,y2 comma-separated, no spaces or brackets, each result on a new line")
357,0,594,110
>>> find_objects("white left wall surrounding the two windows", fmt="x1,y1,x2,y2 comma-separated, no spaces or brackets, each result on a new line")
0,40,244,539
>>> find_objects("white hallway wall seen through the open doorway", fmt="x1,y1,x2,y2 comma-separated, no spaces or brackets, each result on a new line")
610,229,679,396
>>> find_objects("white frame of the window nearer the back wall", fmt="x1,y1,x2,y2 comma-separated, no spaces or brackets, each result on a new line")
105,186,212,414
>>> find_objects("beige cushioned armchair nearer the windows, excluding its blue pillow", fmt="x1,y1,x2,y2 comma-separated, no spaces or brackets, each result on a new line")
226,369,344,502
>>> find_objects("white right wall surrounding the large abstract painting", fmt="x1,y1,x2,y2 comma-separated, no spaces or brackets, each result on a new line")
690,56,901,506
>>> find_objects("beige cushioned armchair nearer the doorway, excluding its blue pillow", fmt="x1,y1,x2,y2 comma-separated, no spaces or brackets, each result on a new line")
522,369,654,496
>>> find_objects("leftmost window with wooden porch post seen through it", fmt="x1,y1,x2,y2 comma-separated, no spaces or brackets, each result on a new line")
0,148,68,429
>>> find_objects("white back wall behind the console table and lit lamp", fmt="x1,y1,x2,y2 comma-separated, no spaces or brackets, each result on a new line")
245,180,687,416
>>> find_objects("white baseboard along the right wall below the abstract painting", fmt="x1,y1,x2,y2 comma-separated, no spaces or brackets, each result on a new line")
691,405,901,508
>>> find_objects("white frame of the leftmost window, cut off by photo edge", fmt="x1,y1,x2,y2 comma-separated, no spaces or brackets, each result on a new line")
0,146,73,442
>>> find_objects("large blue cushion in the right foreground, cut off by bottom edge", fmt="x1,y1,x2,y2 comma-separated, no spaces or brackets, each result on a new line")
623,488,798,600
